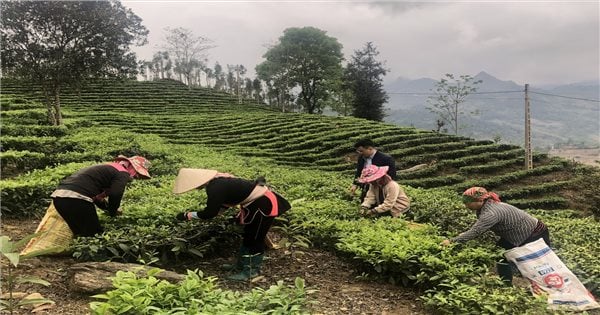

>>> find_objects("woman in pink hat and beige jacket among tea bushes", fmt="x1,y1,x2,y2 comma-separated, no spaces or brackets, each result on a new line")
358,164,410,218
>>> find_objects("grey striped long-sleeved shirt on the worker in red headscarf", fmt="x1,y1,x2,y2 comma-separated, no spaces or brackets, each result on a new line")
452,201,538,246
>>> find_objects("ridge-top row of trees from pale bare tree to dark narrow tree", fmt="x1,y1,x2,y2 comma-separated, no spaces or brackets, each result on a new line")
140,27,387,120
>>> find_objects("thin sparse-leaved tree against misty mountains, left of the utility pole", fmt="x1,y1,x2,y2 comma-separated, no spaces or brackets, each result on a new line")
427,73,482,135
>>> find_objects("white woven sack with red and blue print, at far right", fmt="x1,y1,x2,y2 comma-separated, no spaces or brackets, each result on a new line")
504,239,600,311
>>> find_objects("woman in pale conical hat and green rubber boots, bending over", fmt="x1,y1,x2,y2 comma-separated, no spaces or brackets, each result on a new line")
173,168,291,281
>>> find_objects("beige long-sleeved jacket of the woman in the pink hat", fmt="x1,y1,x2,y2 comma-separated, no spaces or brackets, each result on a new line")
362,181,410,218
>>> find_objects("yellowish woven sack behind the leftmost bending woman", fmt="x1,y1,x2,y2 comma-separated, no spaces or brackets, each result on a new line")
21,203,73,256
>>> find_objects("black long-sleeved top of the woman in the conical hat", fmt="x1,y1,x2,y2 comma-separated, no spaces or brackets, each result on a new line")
197,177,256,219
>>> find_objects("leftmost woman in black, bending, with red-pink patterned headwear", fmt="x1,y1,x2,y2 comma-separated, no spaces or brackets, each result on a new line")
50,155,150,236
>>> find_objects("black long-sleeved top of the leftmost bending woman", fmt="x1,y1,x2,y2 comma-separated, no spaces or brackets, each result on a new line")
57,164,131,215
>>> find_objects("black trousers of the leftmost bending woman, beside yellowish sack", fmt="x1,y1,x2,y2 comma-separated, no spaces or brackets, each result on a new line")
52,198,104,236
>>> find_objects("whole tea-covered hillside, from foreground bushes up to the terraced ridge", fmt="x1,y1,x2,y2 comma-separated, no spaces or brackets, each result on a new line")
0,81,600,315
